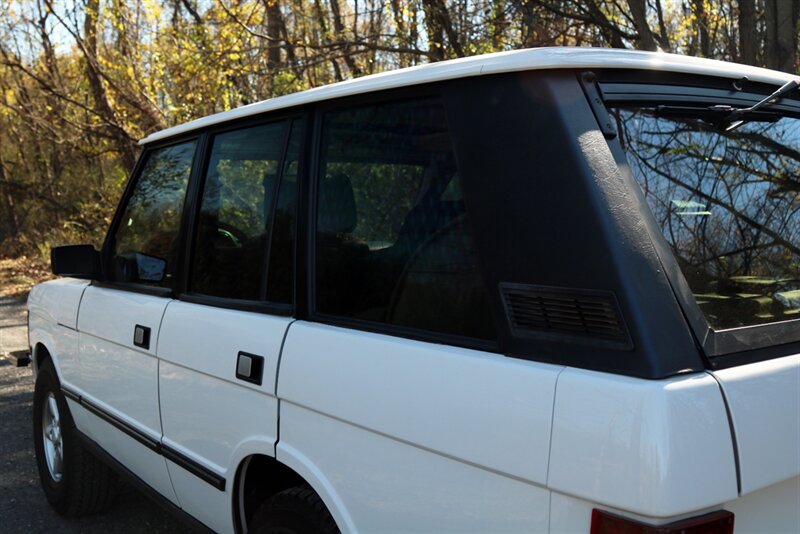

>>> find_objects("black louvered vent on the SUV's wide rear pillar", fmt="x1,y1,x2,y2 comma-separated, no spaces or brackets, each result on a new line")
500,284,630,348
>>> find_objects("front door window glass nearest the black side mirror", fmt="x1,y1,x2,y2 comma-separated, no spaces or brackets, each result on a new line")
111,141,196,287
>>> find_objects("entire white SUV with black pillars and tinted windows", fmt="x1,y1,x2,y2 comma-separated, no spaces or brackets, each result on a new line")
29,49,800,534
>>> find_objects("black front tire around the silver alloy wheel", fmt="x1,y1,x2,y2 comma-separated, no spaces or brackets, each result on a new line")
33,360,117,517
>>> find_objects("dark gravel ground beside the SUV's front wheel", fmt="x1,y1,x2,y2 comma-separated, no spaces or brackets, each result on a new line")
0,297,197,534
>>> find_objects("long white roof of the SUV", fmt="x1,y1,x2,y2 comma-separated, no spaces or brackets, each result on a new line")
139,47,796,145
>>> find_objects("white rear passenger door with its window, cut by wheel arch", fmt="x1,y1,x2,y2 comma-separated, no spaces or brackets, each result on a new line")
158,117,302,532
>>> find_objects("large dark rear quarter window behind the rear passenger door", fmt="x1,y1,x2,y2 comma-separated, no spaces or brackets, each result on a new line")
315,99,496,339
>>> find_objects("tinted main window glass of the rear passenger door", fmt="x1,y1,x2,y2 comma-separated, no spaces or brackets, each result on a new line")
191,122,287,300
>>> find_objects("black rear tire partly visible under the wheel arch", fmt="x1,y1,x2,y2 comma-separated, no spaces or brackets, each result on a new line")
249,486,339,534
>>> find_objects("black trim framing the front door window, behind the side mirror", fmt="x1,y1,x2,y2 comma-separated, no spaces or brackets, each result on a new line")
99,131,205,298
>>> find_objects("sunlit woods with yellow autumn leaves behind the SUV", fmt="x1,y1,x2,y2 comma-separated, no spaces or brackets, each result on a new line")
0,0,800,294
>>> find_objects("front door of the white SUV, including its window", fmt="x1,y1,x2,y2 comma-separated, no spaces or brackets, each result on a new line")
76,140,197,502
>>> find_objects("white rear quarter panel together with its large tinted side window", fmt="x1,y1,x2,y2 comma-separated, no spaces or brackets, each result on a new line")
277,97,561,532
